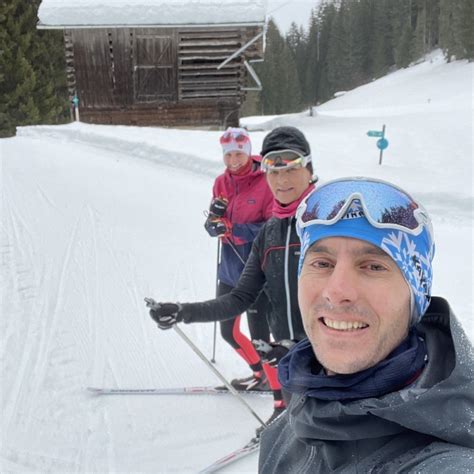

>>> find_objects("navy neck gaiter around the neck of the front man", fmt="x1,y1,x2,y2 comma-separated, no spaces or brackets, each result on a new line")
278,328,428,401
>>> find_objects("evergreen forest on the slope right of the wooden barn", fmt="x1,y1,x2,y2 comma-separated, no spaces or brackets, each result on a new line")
248,0,474,115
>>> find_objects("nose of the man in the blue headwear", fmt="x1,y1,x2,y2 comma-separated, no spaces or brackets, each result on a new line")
322,263,358,305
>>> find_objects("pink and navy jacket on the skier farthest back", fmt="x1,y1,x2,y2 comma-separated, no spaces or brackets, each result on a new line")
212,156,273,286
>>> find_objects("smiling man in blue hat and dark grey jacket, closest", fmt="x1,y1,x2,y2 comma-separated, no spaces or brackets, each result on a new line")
259,178,474,474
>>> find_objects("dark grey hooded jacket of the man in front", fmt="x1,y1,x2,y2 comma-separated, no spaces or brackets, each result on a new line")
259,297,474,474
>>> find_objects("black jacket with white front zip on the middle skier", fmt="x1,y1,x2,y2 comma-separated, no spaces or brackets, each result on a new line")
180,217,306,341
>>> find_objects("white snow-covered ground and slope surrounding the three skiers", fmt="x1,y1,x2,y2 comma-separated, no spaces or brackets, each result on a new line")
0,50,474,473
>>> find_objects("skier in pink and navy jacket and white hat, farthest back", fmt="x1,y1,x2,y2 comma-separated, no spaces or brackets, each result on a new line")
204,128,273,390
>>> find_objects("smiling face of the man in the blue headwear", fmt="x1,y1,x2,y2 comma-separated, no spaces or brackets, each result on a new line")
298,237,410,375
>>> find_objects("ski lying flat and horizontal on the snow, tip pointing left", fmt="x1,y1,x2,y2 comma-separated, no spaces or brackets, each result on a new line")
87,386,272,396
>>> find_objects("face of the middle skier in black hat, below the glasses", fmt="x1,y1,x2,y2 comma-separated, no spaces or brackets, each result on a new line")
266,167,311,204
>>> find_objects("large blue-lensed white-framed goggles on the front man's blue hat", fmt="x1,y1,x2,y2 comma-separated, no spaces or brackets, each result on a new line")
297,177,433,242
